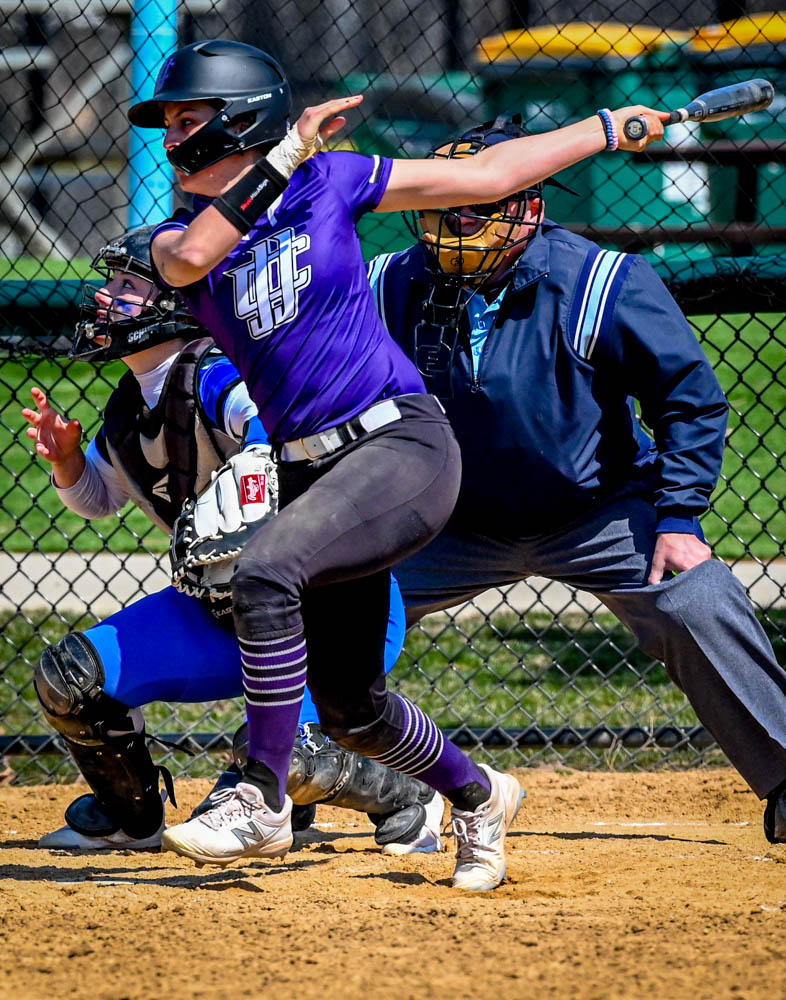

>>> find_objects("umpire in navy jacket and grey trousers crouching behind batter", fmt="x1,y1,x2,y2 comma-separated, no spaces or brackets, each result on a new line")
369,112,786,842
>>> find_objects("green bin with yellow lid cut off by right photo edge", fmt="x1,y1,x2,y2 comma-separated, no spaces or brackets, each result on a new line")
688,11,786,235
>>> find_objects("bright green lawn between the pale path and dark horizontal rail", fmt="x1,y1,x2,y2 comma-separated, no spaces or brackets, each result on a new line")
0,315,786,560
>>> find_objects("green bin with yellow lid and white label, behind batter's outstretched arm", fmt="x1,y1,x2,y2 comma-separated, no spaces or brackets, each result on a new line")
477,22,709,256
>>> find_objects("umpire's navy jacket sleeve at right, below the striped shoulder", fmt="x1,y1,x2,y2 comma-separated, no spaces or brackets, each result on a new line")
594,257,729,534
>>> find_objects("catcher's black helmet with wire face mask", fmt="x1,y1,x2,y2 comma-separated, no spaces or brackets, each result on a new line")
68,226,203,361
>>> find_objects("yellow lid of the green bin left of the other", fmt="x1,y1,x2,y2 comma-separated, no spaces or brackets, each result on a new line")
478,21,692,63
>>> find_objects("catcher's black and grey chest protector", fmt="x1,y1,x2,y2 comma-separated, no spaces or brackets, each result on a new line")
104,338,238,533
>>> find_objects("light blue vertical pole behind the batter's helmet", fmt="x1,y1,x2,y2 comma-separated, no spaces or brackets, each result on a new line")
128,0,178,229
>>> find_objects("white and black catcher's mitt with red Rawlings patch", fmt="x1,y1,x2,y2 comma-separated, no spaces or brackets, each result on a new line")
169,446,278,600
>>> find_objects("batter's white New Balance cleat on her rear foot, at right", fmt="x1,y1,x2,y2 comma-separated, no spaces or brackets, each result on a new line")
451,764,526,892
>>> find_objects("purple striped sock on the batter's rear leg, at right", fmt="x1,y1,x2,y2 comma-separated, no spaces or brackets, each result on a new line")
369,693,490,798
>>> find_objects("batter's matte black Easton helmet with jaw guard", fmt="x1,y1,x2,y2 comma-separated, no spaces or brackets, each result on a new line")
128,39,291,174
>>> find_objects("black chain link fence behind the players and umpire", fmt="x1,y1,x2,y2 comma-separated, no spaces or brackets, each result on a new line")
0,0,786,781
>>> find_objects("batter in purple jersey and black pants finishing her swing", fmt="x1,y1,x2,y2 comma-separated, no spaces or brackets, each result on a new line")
129,40,663,890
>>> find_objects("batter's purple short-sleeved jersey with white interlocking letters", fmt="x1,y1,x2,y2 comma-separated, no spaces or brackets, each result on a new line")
153,152,425,442
